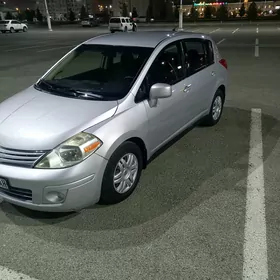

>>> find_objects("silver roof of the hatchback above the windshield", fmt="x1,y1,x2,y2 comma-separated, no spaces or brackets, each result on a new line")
85,31,208,48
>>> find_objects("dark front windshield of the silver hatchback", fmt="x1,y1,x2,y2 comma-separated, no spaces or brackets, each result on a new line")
35,44,153,100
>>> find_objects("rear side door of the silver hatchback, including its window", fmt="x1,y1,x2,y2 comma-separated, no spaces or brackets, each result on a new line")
183,38,216,118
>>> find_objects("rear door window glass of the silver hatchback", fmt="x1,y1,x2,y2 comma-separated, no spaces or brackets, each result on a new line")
183,40,207,75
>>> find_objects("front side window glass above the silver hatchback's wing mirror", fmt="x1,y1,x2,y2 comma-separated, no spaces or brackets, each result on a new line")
147,43,184,88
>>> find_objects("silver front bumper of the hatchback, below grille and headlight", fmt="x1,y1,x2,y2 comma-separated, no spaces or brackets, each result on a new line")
0,154,107,212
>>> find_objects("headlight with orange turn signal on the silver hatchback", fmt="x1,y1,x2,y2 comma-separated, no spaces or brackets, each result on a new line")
35,132,102,169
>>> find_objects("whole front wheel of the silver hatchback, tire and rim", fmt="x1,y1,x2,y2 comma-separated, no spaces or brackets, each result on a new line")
99,141,143,204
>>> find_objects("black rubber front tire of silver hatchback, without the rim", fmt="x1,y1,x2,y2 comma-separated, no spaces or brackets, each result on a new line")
99,141,143,204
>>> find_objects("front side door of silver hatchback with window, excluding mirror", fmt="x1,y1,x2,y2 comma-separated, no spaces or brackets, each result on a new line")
141,42,187,153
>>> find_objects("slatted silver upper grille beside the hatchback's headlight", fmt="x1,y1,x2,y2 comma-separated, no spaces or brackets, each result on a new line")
0,147,46,168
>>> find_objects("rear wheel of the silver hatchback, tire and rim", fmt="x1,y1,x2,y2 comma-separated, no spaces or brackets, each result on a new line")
202,89,225,126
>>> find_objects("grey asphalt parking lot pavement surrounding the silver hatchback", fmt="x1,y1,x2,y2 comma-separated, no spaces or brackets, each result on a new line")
0,22,280,280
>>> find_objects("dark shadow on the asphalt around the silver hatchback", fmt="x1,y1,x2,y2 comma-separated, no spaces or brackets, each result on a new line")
1,107,280,250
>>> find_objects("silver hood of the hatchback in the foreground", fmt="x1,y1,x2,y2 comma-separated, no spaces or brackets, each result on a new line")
0,87,118,150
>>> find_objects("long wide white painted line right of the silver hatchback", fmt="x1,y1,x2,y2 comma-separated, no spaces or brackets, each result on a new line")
243,109,268,280
